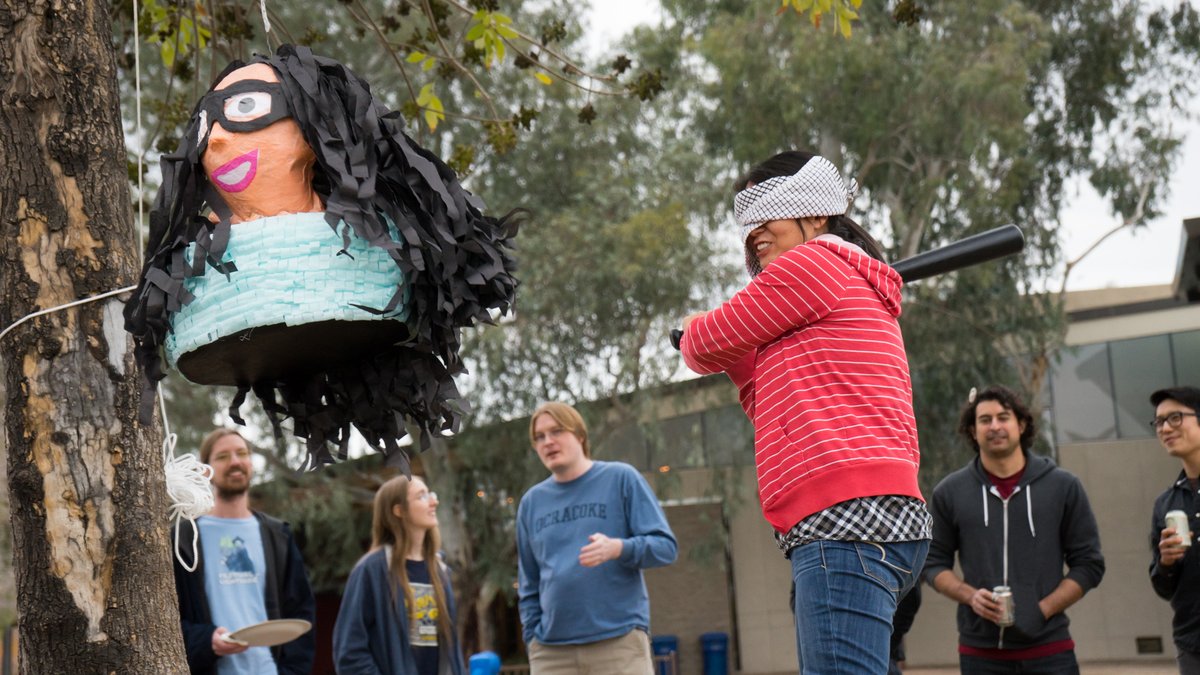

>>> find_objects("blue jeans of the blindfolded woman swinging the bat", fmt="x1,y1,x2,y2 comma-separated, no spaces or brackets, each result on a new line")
788,540,929,675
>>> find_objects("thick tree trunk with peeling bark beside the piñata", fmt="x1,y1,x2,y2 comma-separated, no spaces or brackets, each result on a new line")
0,0,186,674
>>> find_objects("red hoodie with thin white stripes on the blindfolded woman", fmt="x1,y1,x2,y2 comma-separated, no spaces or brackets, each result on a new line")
680,235,922,532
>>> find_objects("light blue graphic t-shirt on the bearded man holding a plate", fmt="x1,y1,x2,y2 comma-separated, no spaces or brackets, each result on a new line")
196,515,277,675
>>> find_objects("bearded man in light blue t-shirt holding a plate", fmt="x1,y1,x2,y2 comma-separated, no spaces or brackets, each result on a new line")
174,429,316,675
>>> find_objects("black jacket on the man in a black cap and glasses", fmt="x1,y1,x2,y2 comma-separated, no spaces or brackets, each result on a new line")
1150,471,1200,653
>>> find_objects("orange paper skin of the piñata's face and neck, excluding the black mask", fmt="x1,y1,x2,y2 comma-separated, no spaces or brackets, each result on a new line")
200,64,324,222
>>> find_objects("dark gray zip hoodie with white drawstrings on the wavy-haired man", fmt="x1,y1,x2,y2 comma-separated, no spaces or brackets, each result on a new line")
923,453,1104,649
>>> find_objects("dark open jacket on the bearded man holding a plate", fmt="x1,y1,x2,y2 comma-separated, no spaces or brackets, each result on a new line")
173,512,317,675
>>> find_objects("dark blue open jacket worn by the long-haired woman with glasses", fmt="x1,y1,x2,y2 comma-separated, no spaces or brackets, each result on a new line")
334,549,466,675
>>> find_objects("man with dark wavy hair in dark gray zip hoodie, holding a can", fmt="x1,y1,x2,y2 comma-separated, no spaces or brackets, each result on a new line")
923,386,1104,675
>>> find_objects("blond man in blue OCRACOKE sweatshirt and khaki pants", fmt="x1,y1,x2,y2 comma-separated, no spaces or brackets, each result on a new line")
517,402,677,675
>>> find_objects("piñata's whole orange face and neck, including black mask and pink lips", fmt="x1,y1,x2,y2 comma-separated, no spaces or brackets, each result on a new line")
198,64,322,222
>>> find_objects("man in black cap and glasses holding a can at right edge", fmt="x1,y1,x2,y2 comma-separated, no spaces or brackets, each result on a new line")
1150,387,1200,675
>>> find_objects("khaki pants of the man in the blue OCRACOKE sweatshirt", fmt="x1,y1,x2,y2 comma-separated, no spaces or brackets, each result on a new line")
529,629,654,675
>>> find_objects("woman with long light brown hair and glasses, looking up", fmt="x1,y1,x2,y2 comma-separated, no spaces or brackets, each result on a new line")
334,476,464,675
